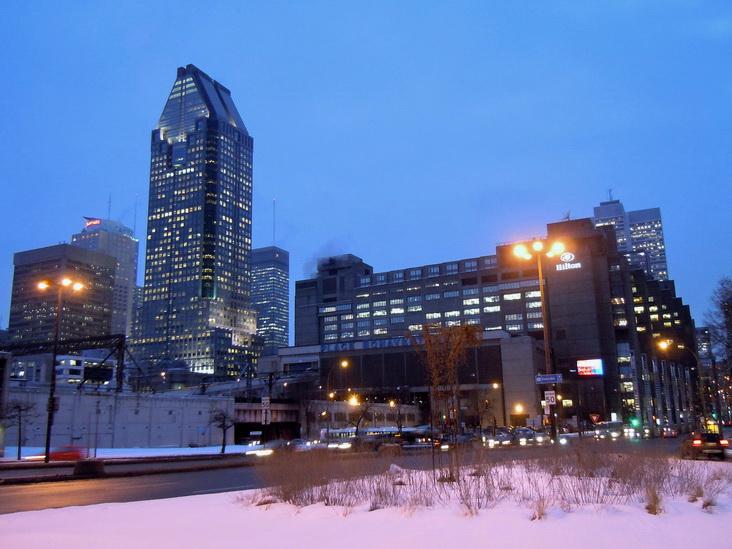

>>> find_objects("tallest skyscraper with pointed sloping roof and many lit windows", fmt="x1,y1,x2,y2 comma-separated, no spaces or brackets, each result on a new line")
137,65,256,379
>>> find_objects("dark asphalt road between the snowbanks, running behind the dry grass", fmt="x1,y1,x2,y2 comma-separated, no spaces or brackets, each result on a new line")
0,439,680,514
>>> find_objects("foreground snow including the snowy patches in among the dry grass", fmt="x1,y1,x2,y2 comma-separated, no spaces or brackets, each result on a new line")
0,458,732,549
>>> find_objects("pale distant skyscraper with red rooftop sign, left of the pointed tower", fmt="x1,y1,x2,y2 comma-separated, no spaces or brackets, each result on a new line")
71,217,139,336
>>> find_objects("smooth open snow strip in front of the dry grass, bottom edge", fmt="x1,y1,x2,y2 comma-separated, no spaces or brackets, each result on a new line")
0,486,732,549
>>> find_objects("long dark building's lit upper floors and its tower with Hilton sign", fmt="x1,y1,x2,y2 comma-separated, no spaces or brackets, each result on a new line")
295,219,690,428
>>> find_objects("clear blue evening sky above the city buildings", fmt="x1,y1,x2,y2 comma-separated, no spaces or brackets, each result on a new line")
0,0,732,334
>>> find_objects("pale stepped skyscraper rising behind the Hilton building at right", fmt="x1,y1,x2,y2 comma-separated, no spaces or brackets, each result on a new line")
594,200,668,280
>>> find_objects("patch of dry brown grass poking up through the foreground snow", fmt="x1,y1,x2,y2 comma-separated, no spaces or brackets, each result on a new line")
248,444,732,520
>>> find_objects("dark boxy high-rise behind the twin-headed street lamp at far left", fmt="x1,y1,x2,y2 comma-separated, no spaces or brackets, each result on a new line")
8,244,117,343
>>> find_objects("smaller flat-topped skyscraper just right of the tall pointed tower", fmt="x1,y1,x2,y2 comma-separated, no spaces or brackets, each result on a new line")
250,246,290,355
